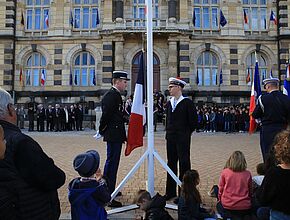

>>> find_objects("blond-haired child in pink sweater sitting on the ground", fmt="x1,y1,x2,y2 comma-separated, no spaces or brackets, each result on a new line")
217,151,252,218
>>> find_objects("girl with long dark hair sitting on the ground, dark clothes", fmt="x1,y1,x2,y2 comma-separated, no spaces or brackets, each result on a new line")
178,170,214,220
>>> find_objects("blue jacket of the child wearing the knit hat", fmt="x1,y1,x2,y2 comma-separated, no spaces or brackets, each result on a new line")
68,178,111,220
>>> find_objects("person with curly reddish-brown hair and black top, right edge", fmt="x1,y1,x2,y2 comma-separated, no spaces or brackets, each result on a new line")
257,130,290,220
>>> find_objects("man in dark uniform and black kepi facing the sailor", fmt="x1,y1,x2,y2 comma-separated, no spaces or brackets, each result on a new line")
99,71,129,207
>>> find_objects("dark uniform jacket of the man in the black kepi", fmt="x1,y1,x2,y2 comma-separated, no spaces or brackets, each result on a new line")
99,87,126,142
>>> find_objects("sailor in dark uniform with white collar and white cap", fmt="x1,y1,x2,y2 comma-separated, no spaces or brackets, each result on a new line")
166,77,197,200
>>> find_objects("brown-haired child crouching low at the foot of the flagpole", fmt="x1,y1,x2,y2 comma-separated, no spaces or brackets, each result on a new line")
134,190,173,220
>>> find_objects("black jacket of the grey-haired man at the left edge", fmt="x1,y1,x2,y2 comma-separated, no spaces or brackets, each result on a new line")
0,120,65,220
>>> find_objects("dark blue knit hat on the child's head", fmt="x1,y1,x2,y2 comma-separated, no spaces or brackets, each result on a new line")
73,150,100,177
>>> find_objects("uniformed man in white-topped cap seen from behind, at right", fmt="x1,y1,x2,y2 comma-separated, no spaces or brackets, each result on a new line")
252,78,290,166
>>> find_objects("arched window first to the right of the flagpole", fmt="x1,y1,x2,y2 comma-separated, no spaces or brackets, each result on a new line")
197,51,218,86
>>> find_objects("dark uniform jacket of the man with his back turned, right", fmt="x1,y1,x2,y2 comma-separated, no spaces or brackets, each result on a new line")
253,90,290,127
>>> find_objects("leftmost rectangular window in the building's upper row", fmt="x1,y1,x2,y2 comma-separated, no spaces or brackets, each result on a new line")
26,0,50,30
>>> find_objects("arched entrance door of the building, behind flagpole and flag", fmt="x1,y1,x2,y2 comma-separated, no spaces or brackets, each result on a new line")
131,51,160,94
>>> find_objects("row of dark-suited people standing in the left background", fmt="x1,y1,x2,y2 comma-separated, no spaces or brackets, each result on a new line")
17,104,84,132
